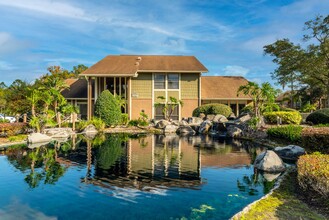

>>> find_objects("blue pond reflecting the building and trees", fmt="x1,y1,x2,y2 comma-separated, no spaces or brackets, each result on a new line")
0,135,274,219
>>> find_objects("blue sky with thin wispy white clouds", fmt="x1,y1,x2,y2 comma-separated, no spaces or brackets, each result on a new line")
0,0,329,85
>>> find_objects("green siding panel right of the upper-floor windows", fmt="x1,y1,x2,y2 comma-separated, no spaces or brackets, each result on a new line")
181,73,199,99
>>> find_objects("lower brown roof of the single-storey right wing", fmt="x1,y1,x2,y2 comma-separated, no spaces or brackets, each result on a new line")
201,76,251,100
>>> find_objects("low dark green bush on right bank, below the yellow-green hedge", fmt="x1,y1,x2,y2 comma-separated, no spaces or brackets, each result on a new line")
267,125,303,142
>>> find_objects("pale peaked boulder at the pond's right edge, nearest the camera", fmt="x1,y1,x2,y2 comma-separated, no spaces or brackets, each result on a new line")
254,150,286,173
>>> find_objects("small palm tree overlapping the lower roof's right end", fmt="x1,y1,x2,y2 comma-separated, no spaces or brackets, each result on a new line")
237,82,279,117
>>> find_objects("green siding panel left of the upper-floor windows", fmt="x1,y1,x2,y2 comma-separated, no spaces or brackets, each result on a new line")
131,73,152,99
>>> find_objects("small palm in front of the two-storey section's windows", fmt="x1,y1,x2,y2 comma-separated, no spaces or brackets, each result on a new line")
154,96,184,120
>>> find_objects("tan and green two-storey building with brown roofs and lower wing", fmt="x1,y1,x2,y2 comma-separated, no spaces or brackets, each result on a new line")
62,55,251,120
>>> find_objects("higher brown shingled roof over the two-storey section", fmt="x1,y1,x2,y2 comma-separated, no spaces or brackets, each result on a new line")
80,55,208,76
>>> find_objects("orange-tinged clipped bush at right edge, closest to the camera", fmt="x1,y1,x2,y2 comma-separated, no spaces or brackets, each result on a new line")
297,154,329,198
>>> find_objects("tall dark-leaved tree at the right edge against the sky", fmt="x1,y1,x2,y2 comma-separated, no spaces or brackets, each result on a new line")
264,15,329,108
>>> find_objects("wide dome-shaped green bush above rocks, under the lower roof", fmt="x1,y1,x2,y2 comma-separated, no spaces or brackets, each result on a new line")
192,104,232,117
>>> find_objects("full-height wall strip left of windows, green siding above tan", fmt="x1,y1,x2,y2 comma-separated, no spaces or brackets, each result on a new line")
131,73,152,119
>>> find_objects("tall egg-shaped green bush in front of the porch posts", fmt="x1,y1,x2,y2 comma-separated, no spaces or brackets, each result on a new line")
95,90,121,126
